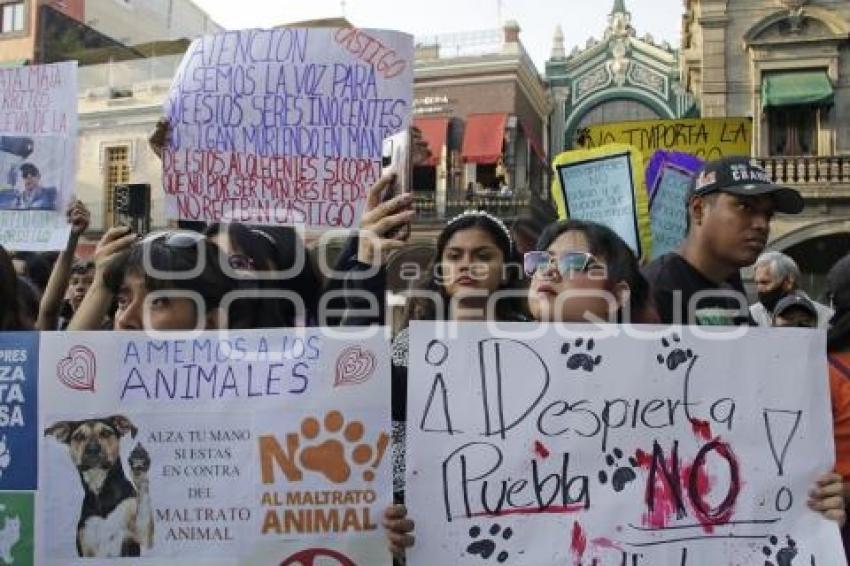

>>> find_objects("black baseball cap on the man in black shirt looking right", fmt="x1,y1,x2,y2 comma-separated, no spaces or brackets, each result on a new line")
689,155,804,214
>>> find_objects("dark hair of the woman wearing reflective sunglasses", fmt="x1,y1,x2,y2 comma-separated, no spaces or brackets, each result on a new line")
537,220,659,323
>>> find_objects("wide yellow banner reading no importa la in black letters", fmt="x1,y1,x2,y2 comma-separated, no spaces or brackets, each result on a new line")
579,118,753,163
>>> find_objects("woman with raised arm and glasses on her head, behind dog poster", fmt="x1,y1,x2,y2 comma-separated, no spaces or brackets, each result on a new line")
69,227,238,330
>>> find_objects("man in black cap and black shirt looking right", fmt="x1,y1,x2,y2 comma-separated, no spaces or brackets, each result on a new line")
644,157,803,325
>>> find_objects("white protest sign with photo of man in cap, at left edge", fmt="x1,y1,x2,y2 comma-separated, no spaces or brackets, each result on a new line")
0,61,77,251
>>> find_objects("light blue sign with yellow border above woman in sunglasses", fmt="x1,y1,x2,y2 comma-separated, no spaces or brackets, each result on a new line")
552,144,652,257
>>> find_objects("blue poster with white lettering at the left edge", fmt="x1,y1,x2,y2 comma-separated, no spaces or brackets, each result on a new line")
0,332,38,491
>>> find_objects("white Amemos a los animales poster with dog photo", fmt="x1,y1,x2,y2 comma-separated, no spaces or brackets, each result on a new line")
36,329,391,566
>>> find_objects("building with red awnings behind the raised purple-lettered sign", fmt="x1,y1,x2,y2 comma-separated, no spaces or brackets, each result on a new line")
413,21,551,227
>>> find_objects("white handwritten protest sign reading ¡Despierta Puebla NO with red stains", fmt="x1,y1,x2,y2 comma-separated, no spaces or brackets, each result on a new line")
406,322,845,566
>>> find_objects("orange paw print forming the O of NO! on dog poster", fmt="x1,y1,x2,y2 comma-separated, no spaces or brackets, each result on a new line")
300,411,389,483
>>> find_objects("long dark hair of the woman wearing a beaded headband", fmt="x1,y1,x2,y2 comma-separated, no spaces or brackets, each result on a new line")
403,212,528,327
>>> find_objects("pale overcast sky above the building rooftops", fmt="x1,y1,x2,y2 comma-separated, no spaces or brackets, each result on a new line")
195,0,682,73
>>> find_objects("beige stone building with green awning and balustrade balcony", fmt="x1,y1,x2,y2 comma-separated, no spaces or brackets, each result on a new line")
680,0,850,292
